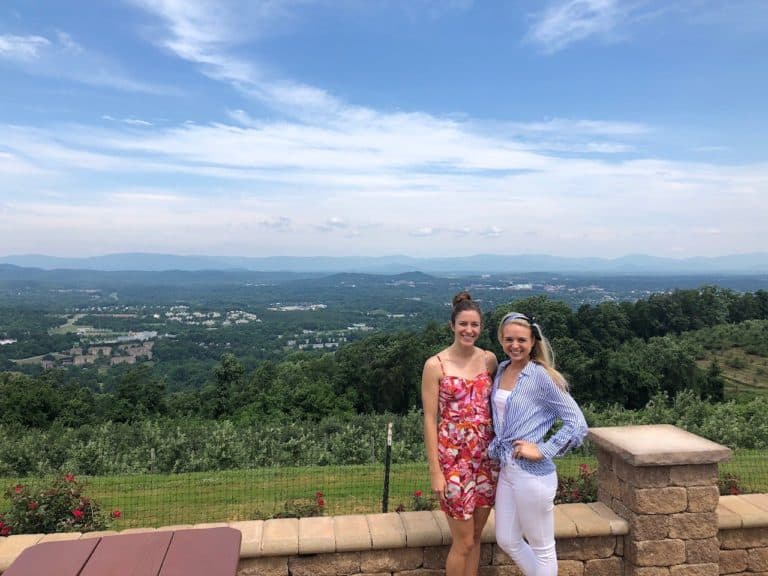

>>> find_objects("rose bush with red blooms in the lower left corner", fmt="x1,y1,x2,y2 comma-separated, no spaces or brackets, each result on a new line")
2,474,120,534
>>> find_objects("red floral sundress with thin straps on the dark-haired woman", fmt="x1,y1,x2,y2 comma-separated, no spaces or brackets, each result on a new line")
437,356,499,520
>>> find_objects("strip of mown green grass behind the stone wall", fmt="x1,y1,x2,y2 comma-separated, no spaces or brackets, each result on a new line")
0,450,768,529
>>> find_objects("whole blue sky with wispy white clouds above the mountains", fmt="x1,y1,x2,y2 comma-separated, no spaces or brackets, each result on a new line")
0,0,768,258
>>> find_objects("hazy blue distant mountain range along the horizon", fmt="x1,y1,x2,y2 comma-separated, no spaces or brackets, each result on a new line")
0,252,768,275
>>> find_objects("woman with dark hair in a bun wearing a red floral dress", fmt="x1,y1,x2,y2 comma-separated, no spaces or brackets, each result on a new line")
421,292,498,576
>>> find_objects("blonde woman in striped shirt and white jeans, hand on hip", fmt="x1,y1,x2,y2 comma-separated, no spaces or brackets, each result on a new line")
489,312,587,576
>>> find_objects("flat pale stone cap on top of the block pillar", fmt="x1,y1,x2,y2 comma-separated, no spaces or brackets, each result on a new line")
589,424,732,466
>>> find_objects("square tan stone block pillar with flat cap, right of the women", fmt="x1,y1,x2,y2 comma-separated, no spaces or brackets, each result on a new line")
589,425,731,576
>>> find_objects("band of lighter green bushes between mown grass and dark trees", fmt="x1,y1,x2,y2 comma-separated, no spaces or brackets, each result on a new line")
0,390,768,478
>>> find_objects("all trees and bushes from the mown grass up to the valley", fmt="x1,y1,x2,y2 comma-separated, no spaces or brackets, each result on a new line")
0,286,768,477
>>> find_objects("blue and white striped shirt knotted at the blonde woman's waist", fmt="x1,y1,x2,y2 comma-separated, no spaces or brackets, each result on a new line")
488,360,587,476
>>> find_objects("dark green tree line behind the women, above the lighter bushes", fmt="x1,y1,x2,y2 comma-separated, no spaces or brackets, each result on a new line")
0,286,768,429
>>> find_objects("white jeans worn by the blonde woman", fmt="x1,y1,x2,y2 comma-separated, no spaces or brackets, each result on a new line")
496,462,557,576
